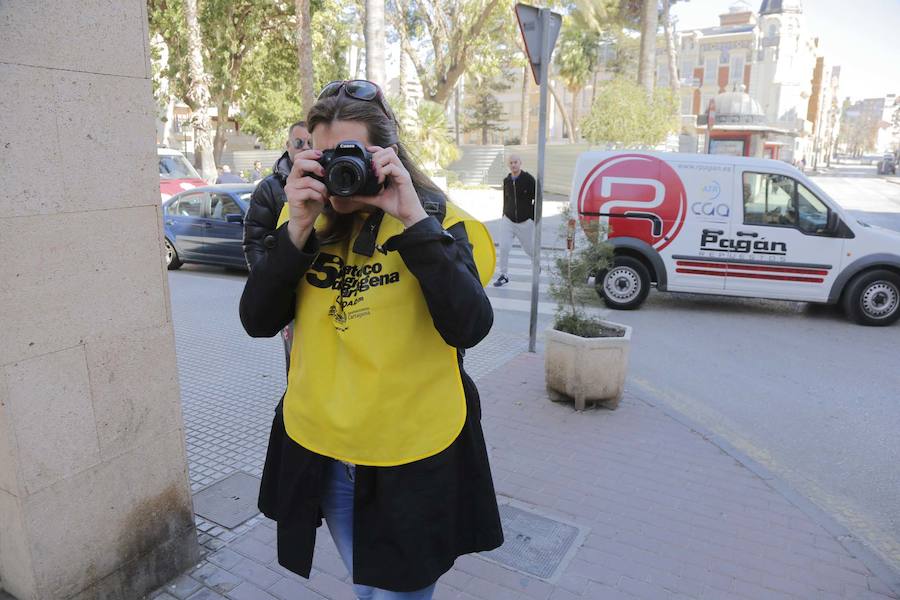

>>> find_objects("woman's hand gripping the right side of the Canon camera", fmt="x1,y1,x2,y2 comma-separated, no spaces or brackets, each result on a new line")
357,146,428,227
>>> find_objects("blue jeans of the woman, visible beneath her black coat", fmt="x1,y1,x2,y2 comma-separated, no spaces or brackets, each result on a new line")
322,460,435,600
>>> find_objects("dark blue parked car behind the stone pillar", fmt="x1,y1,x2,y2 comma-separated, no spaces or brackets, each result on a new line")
163,183,254,270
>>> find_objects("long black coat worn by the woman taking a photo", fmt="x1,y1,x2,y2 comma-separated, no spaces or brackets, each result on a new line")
241,206,503,591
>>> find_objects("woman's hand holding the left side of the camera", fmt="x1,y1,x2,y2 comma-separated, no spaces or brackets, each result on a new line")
284,150,328,249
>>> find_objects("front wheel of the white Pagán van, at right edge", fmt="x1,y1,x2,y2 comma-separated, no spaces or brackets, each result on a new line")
843,269,900,326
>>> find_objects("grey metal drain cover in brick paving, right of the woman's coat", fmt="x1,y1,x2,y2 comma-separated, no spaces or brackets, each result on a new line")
481,504,581,579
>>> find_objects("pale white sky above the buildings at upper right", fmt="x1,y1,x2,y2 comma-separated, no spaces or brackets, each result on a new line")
672,0,900,101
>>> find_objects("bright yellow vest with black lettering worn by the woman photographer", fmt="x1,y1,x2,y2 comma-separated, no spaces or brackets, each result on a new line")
278,202,495,467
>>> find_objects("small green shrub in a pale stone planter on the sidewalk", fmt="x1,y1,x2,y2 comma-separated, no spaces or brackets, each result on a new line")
544,208,631,410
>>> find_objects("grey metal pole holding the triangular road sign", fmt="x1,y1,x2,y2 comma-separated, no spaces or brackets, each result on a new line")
528,8,553,352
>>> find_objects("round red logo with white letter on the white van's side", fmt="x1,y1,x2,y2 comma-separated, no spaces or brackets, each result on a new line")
578,154,687,250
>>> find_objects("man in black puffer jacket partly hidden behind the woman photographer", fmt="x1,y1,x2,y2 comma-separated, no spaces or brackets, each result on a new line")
244,121,309,270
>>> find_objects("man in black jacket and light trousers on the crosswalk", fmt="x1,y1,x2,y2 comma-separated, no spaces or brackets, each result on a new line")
494,154,536,287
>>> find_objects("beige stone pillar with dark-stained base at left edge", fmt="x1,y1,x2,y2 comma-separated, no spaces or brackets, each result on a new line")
0,0,198,600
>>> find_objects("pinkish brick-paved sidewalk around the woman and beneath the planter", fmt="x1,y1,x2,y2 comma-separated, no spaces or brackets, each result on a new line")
151,344,898,600
